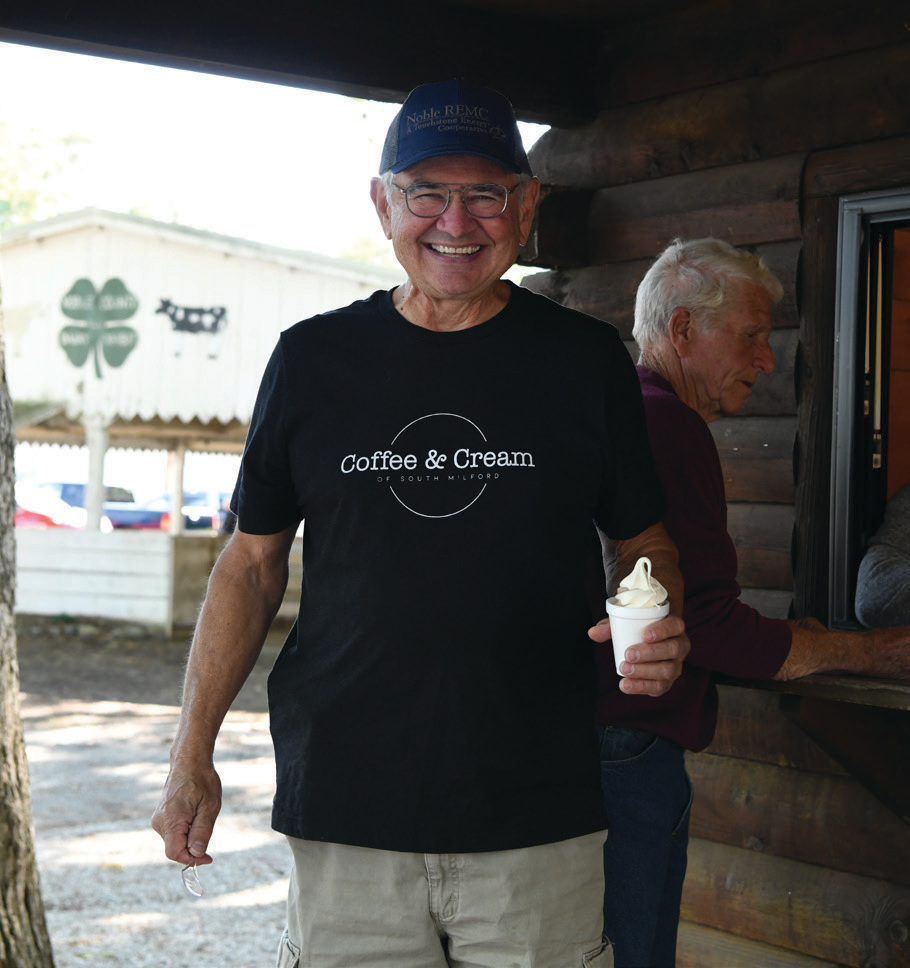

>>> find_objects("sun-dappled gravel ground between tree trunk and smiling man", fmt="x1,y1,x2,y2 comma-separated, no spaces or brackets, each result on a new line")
17,615,289,968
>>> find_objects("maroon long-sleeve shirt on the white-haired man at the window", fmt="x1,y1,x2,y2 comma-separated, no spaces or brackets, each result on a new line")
597,366,792,750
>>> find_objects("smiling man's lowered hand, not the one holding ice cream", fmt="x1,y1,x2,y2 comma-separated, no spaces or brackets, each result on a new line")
152,765,221,865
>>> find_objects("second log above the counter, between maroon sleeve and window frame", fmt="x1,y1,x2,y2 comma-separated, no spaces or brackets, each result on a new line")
727,504,793,590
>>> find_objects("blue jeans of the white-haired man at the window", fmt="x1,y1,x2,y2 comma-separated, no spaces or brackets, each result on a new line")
597,726,692,968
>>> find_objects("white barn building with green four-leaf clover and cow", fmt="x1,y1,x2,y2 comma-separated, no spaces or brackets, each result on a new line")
0,209,404,625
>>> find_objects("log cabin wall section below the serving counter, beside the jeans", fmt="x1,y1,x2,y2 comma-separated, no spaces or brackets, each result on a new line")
677,685,910,968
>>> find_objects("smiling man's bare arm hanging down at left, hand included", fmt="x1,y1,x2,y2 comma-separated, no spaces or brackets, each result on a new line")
152,526,296,864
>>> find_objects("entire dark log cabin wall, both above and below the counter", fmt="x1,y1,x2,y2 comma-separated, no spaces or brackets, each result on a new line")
525,2,910,968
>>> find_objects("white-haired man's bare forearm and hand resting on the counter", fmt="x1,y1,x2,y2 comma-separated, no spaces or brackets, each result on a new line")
774,618,910,680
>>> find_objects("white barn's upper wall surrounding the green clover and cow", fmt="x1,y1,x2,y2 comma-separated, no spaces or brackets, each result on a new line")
0,212,403,423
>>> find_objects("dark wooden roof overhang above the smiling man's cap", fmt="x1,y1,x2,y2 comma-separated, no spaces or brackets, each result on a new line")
0,0,628,124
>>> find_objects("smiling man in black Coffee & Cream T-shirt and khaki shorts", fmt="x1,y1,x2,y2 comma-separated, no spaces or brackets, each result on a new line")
154,80,688,968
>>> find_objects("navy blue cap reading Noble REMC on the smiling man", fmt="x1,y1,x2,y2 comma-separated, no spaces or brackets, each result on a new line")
379,78,532,175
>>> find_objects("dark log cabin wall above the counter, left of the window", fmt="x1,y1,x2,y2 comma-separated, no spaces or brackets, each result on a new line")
527,2,910,618
